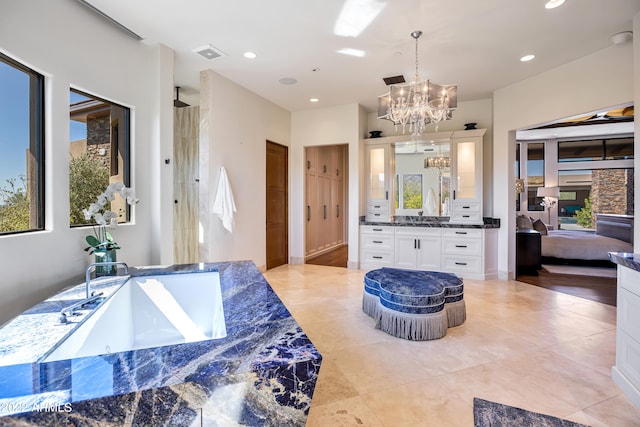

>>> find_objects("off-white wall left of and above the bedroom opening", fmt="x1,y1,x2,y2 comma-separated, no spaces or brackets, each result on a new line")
493,42,638,279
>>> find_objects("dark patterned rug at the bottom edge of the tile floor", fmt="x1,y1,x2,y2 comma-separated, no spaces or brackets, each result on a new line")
473,397,587,427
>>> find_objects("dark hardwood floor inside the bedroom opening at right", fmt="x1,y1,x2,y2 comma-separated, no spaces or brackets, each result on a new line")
516,269,617,307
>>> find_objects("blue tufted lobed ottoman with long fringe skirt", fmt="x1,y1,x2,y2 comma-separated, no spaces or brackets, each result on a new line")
362,267,467,341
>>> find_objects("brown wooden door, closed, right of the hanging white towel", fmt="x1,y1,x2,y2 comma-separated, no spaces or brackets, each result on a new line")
266,141,289,270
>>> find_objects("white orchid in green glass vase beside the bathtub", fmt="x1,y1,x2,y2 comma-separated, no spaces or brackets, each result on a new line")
82,182,138,276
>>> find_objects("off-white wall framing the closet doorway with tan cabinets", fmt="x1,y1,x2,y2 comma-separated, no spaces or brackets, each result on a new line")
289,104,364,268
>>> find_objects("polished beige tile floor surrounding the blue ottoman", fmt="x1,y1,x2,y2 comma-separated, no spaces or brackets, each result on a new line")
265,264,640,427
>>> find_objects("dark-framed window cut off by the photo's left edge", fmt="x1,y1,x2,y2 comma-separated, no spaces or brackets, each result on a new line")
0,53,44,234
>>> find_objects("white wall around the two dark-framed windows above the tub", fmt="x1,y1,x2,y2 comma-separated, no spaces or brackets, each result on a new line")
0,0,173,323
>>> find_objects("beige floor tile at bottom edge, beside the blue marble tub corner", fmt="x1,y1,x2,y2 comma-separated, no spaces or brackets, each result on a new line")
306,397,384,427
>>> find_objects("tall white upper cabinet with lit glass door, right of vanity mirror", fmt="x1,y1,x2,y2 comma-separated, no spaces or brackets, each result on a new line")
449,129,486,224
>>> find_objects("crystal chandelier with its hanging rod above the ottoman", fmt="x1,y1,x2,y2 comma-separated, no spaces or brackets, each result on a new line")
378,31,458,139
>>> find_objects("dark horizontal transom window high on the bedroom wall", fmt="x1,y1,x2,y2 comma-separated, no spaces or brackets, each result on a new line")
558,138,633,162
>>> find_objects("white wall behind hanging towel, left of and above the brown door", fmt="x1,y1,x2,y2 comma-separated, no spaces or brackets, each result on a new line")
200,70,295,268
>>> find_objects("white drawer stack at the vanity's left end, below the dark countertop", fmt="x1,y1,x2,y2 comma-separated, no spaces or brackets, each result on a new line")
360,225,394,270
